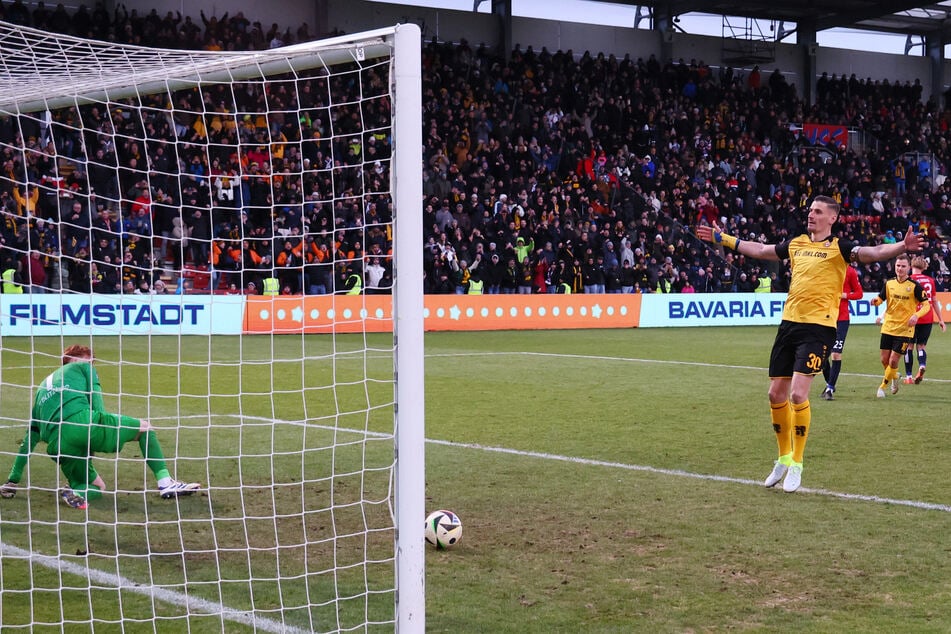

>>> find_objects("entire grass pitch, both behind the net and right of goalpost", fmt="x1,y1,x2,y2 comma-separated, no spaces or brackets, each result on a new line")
0,326,951,632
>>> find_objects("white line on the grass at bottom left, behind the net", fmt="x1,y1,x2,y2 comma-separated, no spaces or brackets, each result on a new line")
0,543,310,634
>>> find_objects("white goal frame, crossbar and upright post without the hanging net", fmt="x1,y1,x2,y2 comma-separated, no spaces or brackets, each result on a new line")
0,23,426,634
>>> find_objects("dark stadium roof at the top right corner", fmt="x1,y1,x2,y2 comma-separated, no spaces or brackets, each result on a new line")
628,0,951,44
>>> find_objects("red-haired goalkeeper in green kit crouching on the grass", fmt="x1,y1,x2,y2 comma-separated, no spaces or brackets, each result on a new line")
0,345,201,509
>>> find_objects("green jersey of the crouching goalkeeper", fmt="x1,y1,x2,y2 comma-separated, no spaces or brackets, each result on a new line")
32,361,105,441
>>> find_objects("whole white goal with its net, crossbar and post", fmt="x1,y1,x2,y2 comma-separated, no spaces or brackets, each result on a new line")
0,23,425,632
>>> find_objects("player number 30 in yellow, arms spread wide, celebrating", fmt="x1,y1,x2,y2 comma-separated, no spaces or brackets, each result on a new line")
697,196,922,492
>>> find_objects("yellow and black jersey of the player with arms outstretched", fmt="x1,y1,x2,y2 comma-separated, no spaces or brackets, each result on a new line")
776,234,855,328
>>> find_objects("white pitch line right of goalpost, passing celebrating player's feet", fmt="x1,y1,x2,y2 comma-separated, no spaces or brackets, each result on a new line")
426,439,951,513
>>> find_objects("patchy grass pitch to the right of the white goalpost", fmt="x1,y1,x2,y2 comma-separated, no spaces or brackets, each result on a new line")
427,326,951,632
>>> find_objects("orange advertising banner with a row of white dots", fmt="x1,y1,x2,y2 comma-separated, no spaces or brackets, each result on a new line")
244,294,641,334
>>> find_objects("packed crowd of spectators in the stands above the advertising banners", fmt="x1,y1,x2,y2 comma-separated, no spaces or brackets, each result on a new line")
0,0,951,294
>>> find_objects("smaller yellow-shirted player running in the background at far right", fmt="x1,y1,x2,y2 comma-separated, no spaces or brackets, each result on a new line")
872,255,931,398
